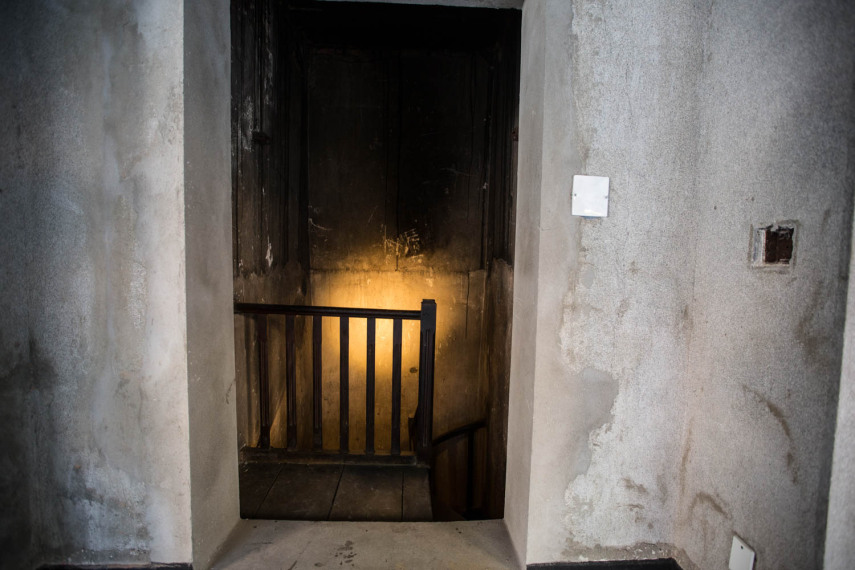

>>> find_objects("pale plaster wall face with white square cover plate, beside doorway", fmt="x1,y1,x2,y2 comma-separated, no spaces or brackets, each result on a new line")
514,2,701,563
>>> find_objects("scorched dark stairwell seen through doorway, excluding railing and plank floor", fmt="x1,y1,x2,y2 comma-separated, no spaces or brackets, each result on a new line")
232,0,520,519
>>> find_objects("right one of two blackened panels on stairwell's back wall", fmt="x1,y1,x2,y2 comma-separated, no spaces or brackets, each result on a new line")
398,51,488,271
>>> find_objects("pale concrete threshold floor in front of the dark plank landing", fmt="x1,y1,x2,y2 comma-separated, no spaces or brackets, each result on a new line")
213,520,521,570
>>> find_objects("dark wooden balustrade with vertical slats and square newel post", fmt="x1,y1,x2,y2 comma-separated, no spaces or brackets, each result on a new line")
234,299,436,461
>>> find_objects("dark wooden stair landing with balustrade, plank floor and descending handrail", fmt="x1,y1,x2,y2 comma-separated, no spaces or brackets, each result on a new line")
235,299,486,521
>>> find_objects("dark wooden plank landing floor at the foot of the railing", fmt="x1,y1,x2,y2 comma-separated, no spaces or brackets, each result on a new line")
240,462,433,522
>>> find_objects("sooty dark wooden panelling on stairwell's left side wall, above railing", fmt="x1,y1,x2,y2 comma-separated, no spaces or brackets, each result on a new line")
232,0,292,277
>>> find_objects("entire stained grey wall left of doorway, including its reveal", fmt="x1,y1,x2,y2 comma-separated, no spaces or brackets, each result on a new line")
0,1,238,568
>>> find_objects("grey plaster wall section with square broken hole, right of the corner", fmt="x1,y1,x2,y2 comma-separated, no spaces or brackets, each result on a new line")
677,1,855,570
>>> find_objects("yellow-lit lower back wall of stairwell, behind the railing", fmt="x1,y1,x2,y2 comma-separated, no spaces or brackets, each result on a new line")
260,271,484,453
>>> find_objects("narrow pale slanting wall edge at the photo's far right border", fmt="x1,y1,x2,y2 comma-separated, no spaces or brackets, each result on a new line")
823,202,855,570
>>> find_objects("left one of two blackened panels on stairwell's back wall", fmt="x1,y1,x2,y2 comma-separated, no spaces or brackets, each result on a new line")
308,50,390,269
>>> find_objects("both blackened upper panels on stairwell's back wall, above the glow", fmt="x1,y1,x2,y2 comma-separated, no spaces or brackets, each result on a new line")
308,44,490,271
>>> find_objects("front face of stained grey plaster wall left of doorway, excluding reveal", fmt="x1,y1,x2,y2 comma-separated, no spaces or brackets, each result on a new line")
0,0,190,567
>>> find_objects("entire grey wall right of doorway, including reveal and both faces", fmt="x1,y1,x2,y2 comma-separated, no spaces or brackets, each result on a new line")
506,0,853,568
